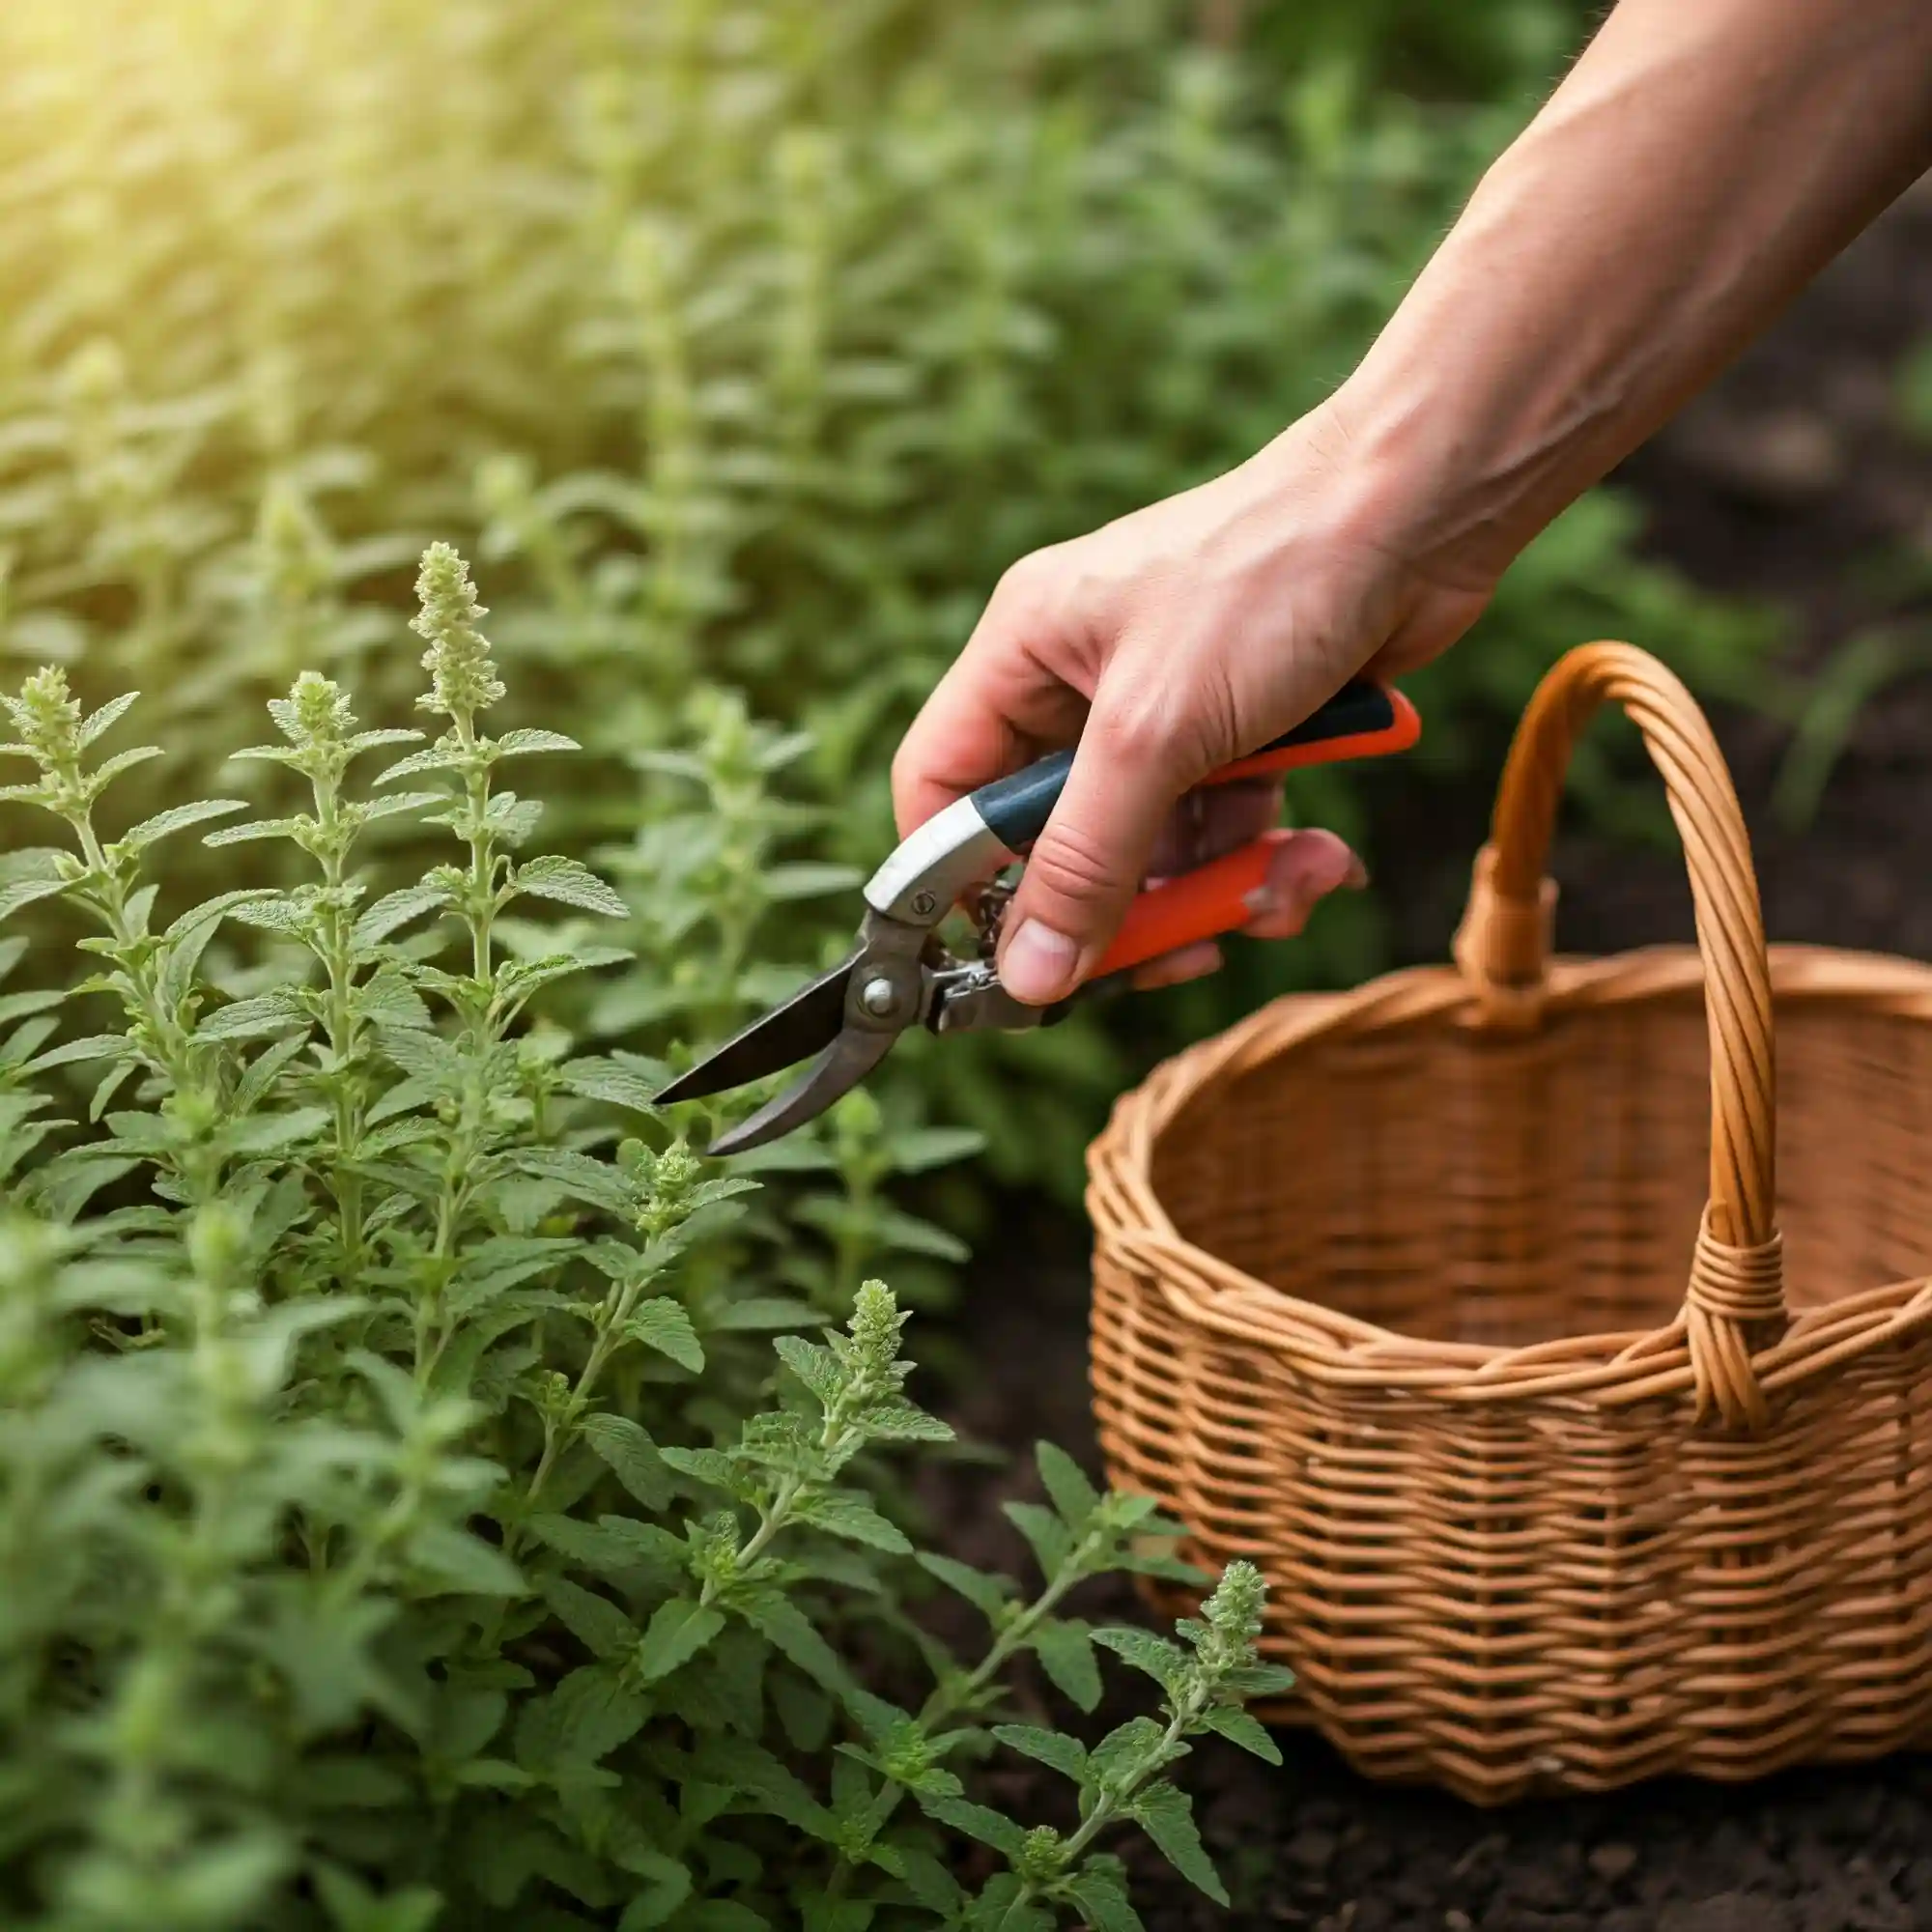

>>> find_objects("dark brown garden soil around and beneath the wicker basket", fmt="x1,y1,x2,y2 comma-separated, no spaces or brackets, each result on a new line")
912,178,1932,1932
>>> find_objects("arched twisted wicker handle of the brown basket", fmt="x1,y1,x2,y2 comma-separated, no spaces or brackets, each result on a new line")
1455,643,1787,1428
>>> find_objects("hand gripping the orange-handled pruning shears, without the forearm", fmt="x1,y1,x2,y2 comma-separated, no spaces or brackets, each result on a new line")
893,410,1493,1005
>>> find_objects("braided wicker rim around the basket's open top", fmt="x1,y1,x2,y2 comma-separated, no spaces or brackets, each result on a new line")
1086,943,1932,1408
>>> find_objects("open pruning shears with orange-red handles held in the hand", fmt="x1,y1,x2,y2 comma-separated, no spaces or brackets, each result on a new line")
655,678,1422,1155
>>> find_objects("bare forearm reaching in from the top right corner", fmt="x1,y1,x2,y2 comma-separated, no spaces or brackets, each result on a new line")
1314,0,1932,582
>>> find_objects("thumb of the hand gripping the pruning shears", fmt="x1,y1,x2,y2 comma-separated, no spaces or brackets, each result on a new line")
999,713,1186,1007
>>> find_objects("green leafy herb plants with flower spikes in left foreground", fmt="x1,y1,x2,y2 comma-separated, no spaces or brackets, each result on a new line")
0,545,1287,1932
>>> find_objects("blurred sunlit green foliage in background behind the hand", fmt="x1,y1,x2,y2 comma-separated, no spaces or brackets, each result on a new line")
0,0,1754,1215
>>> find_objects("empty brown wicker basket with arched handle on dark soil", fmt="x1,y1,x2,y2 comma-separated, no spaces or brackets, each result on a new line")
1088,643,1932,1803
